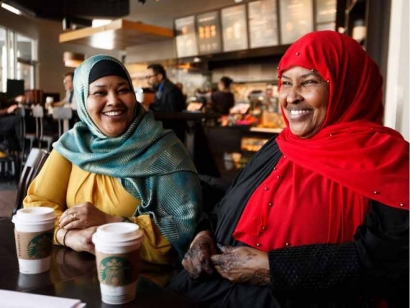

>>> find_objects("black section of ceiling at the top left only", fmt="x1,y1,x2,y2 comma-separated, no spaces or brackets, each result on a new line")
4,0,130,21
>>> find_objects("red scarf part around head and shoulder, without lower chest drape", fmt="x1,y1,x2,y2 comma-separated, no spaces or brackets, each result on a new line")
276,31,409,210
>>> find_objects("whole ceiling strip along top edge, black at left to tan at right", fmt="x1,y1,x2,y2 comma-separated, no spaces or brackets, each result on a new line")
0,0,242,28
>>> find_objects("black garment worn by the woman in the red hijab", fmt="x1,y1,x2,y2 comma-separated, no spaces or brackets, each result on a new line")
169,138,409,307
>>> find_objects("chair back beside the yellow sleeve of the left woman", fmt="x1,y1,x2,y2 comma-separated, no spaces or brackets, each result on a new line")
12,148,49,215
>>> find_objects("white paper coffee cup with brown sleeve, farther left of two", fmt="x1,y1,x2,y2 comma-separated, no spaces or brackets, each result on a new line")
12,207,57,274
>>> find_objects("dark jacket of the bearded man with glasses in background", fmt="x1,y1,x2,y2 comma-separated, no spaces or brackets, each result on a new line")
150,79,186,112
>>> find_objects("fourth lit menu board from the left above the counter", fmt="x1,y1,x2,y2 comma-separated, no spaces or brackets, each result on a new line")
248,0,279,48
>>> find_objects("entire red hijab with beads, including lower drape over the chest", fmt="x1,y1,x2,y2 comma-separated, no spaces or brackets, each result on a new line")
233,31,409,251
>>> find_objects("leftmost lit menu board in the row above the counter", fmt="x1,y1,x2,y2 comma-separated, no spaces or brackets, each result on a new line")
175,16,198,58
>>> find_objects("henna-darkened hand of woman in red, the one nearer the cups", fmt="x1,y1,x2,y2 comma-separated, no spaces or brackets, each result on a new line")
182,231,217,278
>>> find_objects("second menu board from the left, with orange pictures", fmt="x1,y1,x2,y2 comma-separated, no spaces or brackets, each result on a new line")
196,11,222,55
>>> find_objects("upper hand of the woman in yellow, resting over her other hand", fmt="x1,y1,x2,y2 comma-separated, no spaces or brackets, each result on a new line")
59,202,122,230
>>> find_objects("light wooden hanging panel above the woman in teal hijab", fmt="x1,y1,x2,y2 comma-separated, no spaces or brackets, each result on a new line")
59,19,174,50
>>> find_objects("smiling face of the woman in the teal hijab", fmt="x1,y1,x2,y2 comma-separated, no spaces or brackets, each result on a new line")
86,75,136,137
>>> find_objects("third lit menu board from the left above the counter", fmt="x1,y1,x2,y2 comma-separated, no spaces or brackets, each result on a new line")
221,4,248,51
